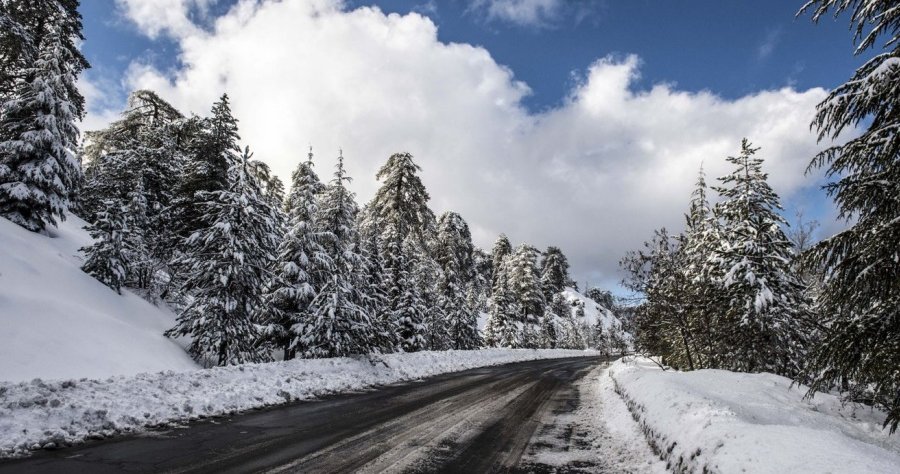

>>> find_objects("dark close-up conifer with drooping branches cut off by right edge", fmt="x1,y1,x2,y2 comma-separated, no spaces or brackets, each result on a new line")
804,0,900,432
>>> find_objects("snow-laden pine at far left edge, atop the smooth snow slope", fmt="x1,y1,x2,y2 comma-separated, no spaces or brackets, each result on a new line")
0,18,86,232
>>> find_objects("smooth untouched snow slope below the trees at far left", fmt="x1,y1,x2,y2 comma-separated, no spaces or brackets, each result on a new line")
0,216,197,381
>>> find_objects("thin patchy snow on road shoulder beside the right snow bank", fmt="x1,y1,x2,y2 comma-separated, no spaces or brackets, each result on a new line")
524,365,667,474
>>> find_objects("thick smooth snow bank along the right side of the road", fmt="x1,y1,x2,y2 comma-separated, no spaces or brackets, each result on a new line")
610,358,900,473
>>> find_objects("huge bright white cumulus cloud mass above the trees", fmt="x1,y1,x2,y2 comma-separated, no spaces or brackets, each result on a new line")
89,0,826,285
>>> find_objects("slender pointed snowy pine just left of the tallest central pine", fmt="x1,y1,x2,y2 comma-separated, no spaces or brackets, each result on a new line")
303,153,378,357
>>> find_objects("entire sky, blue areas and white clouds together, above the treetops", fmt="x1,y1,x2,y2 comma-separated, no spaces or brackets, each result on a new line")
81,0,865,286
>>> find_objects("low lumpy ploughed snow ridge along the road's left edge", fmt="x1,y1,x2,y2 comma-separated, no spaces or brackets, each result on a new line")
0,349,597,457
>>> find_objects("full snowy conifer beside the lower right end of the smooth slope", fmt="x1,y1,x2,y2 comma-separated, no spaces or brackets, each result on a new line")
166,147,279,366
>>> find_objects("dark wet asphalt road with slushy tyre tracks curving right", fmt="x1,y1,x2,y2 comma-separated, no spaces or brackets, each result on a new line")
0,358,601,474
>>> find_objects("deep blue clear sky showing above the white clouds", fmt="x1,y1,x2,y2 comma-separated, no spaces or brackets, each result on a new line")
81,0,862,110
